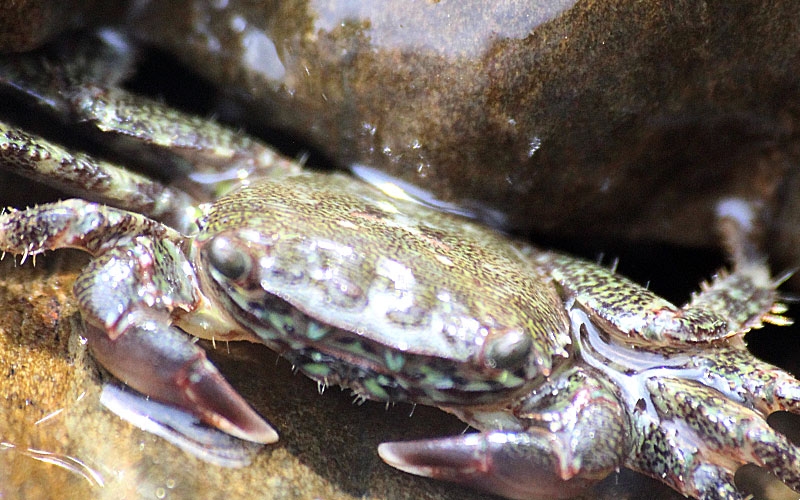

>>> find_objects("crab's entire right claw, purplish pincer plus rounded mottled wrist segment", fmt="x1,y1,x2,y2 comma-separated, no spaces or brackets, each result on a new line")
378,367,631,500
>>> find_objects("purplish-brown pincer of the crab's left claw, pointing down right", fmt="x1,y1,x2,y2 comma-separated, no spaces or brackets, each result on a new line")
86,321,278,444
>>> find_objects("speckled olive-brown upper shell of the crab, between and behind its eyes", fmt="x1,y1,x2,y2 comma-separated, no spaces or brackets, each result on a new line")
205,176,569,365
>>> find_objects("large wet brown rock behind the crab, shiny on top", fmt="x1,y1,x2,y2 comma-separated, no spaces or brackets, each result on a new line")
126,0,800,265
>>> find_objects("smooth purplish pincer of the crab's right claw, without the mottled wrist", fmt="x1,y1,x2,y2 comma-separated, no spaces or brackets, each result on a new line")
378,429,614,500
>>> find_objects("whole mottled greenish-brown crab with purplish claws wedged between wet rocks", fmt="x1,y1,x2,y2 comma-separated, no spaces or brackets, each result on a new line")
0,34,800,499
